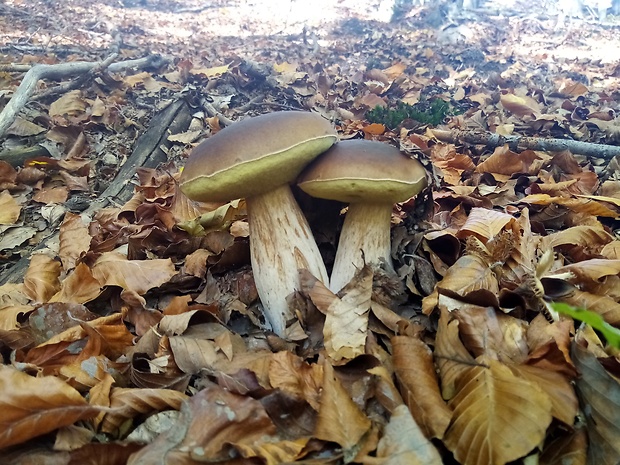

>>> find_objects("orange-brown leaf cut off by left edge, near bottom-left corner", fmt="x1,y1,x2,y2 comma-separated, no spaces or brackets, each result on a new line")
0,365,101,449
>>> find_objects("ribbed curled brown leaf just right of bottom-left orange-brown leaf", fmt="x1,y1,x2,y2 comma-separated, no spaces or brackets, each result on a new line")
101,388,188,435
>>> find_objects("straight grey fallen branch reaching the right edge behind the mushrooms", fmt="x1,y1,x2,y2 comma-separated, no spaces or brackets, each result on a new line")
431,129,620,160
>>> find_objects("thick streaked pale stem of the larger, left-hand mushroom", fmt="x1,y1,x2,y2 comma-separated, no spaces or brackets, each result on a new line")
246,184,329,336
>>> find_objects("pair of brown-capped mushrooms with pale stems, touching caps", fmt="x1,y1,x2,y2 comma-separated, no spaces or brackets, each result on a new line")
180,111,426,336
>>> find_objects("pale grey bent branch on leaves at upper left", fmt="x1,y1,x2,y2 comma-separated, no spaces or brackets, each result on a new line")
0,55,166,138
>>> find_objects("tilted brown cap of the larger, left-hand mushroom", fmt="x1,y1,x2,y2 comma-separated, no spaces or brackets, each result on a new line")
179,111,338,202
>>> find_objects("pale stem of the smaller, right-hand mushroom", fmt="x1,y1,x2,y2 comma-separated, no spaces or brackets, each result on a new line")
329,202,393,293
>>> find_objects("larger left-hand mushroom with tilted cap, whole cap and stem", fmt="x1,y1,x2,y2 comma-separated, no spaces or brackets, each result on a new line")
179,111,338,336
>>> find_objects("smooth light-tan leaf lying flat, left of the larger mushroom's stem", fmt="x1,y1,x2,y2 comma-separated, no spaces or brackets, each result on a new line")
92,252,176,294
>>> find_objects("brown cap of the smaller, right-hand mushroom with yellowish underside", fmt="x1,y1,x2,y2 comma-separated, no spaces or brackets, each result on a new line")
298,140,426,203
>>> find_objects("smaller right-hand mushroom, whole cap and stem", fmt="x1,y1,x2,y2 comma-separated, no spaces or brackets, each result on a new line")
298,140,426,292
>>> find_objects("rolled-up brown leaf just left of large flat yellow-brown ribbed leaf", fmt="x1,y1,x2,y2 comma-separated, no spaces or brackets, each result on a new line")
392,336,452,439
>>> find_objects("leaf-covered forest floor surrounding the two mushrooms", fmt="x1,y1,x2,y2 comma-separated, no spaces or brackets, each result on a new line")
0,0,620,465
